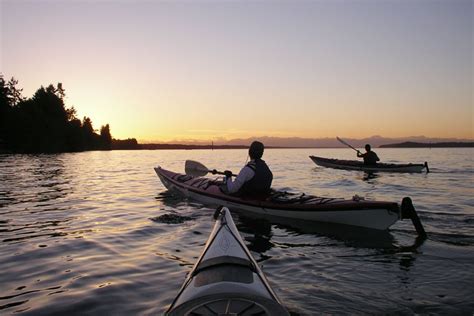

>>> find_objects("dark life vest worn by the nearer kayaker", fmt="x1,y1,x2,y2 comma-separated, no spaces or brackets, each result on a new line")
239,159,273,195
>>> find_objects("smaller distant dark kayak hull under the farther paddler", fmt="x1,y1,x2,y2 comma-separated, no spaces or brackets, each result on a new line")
309,156,426,173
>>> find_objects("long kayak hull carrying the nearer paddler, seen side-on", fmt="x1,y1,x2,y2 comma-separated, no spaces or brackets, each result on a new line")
155,167,400,230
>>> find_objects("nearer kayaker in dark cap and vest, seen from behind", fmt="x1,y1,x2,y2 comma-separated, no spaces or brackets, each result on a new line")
225,141,273,195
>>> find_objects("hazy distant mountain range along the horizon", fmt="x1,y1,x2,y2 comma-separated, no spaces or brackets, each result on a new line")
147,136,474,148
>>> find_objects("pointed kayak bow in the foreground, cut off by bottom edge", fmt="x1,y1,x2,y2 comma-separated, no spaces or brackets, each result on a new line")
166,208,289,316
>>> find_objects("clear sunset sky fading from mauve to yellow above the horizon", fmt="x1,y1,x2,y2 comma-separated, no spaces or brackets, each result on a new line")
0,0,474,142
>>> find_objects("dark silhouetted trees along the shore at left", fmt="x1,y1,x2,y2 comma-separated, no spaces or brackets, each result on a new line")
0,74,137,153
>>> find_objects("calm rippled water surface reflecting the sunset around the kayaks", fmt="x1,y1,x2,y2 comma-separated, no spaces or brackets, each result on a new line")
0,149,474,315
